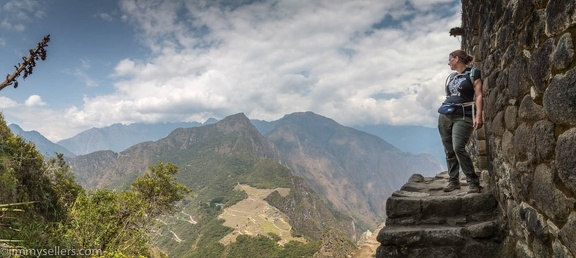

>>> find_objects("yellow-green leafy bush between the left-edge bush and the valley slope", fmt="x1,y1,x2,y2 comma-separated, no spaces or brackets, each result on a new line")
63,162,189,257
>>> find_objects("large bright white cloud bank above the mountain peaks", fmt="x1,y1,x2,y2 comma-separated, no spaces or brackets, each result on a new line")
7,0,461,141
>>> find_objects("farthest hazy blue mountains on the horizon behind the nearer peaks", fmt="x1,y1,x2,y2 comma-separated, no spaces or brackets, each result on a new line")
9,112,446,169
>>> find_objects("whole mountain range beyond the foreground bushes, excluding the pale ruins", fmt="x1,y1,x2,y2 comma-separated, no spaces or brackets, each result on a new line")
11,112,442,257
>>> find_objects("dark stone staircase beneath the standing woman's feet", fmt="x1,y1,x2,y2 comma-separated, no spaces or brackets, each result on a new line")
375,172,505,258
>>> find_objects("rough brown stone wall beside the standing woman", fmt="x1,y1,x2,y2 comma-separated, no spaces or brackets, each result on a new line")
461,0,576,257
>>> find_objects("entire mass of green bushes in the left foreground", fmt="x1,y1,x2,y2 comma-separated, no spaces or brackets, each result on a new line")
0,115,189,257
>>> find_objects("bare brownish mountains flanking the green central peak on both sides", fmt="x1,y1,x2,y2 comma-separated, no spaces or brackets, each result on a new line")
63,112,442,228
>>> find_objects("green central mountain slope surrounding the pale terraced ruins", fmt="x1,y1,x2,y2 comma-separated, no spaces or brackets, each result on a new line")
136,116,354,257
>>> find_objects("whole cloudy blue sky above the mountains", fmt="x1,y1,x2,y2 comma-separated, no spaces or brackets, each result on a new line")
0,0,461,141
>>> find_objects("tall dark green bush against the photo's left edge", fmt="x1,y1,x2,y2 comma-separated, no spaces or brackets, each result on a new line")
0,114,84,249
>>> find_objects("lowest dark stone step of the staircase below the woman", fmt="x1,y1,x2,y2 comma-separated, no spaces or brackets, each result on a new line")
376,221,503,258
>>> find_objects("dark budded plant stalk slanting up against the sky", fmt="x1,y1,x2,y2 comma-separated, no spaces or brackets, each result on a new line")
0,34,50,90
